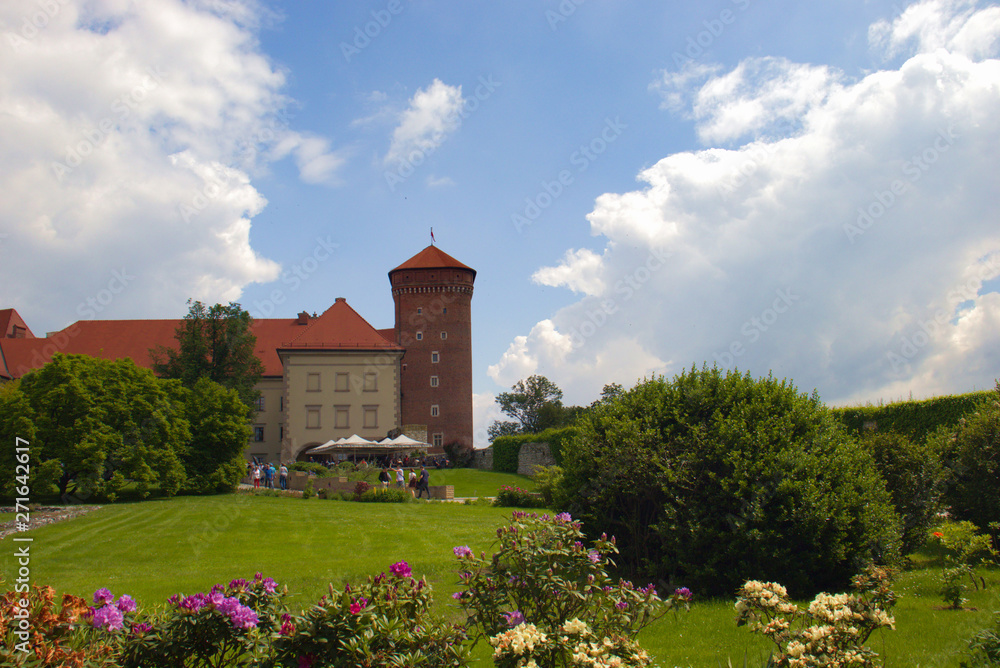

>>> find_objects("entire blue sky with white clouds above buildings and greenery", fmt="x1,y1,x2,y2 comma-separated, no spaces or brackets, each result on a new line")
0,0,1000,446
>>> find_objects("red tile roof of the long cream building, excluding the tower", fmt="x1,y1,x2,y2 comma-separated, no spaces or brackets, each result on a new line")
0,300,403,378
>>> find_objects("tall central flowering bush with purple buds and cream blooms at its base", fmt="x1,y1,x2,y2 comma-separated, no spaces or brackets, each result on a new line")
453,511,691,668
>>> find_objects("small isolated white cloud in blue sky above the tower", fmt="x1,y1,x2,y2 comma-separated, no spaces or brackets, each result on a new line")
385,79,465,164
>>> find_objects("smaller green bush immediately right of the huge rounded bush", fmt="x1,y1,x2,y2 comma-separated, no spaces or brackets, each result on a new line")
861,431,945,554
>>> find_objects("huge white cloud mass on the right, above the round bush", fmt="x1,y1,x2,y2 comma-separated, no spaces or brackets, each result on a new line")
490,1,1000,403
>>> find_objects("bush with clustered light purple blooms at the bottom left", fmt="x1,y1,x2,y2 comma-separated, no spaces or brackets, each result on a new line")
120,573,285,668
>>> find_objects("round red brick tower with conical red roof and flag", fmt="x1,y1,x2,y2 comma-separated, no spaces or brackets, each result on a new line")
389,245,476,452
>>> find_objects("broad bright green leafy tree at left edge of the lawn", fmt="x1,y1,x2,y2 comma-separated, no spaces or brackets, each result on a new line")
20,354,188,500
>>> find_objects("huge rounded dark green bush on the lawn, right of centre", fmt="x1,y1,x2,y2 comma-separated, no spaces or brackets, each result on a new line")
557,367,900,596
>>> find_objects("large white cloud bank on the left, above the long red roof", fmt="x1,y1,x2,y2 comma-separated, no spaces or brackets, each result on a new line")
0,0,343,324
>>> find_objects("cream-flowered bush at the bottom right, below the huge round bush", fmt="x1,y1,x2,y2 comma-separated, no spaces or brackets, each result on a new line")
736,567,896,668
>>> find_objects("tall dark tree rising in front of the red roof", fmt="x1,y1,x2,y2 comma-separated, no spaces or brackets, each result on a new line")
149,300,264,410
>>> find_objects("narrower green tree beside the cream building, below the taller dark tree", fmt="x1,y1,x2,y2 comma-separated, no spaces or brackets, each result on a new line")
166,378,252,494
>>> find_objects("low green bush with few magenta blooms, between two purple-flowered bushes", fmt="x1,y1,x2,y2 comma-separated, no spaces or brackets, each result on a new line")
273,561,467,668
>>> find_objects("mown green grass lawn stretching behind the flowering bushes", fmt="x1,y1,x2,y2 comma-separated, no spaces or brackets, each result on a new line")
0,488,1000,668
